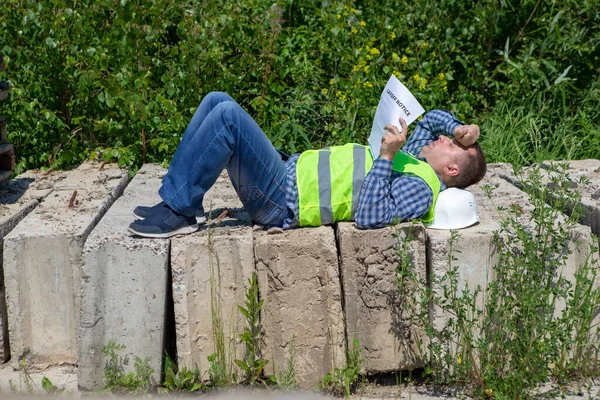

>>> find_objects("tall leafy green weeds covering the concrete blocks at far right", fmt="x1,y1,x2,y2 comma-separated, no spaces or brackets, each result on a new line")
398,162,600,398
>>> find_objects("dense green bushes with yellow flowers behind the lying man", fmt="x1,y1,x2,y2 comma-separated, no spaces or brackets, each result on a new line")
0,0,600,171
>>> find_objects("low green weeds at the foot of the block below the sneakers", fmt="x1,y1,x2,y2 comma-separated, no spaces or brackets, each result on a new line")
102,340,155,393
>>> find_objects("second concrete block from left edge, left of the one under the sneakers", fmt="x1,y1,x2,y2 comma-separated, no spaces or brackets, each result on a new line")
4,163,128,367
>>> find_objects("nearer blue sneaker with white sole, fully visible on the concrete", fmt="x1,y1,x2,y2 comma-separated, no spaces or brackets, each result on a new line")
128,204,198,238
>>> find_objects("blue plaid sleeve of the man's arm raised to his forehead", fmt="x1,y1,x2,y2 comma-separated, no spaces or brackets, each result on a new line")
402,110,464,156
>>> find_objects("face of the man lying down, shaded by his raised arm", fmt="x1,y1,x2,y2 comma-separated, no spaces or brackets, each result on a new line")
419,135,475,177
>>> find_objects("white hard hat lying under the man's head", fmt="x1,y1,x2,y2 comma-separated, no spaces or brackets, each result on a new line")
426,188,479,229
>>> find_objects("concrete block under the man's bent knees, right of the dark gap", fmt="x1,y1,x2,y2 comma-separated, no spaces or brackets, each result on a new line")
171,172,254,377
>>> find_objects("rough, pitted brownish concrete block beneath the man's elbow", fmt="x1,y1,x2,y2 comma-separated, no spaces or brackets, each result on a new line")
336,222,427,374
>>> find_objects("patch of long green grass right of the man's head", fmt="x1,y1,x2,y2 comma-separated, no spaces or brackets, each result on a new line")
481,78,600,167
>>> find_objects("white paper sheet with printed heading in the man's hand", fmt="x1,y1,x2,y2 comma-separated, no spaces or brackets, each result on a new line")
369,75,425,159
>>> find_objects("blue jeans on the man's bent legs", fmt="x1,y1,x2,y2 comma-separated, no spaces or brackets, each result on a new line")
158,92,287,226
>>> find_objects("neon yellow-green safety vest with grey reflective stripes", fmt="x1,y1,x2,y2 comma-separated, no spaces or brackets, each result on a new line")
296,143,440,226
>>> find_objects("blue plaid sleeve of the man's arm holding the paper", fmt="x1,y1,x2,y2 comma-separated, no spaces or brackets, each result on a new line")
354,158,433,229
